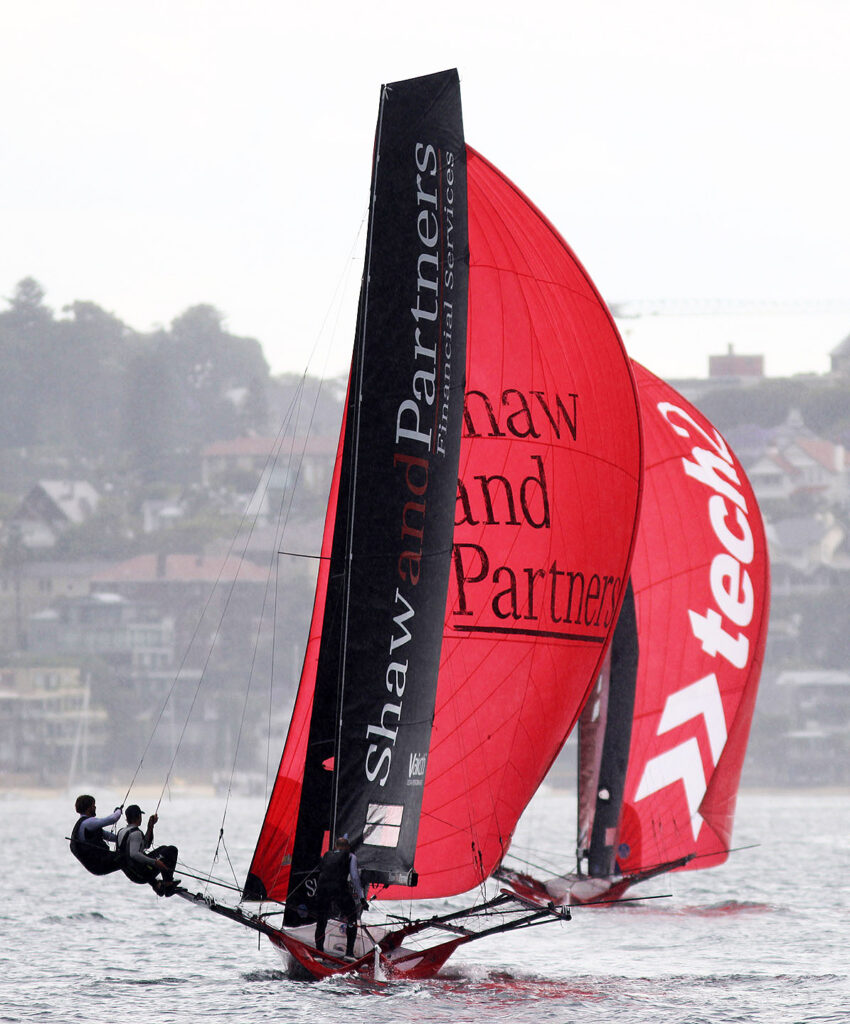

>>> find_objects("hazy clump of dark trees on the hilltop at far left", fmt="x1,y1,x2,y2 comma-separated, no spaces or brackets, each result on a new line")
0,278,269,468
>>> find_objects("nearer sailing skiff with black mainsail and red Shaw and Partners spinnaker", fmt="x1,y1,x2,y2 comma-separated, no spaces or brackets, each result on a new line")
114,71,642,979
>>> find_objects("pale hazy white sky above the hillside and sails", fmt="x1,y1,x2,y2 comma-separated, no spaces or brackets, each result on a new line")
0,0,850,377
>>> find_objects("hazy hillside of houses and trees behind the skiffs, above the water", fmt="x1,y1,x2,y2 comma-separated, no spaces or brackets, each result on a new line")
0,283,850,785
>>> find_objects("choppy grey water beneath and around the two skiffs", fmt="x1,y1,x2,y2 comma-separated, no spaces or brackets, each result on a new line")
0,791,850,1024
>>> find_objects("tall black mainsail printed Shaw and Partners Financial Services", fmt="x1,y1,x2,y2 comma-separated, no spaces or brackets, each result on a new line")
333,72,467,884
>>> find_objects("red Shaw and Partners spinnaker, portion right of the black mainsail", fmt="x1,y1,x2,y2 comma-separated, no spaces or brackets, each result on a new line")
403,147,642,897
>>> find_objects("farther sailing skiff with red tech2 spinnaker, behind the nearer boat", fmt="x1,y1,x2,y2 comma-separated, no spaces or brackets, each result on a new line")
497,364,770,905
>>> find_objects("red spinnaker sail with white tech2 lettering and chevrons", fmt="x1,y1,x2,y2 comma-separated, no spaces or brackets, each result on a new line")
618,364,770,872
